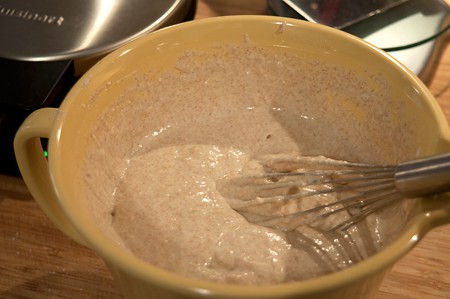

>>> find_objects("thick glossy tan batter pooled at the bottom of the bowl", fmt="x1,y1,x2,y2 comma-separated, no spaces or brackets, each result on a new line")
114,145,386,284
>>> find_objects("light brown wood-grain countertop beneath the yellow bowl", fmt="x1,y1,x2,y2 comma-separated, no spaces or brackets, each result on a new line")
0,0,450,299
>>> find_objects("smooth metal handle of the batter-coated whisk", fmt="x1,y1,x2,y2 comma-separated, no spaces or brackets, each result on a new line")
395,154,450,197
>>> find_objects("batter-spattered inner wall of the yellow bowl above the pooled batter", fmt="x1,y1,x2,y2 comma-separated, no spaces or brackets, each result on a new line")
55,19,441,251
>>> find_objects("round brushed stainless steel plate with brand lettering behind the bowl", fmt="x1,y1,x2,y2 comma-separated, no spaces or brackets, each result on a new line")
0,0,195,61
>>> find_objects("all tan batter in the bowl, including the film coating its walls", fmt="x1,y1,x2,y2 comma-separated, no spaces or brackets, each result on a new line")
85,41,415,285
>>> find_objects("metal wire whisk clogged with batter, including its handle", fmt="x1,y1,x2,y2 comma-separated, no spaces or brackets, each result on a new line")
218,153,450,231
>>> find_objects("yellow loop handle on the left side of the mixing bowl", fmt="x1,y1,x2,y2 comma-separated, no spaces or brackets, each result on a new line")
14,108,89,247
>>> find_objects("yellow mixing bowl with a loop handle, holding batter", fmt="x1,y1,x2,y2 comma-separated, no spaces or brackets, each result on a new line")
14,16,450,299
